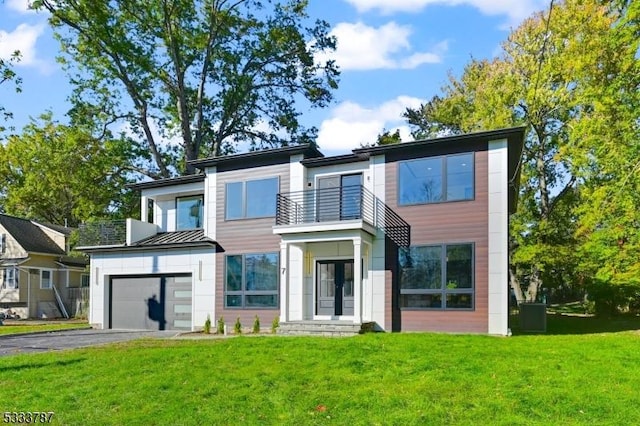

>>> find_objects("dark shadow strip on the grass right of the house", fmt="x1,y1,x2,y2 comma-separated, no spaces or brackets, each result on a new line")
509,313,640,336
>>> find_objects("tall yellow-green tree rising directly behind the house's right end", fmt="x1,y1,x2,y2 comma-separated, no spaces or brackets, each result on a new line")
405,0,629,306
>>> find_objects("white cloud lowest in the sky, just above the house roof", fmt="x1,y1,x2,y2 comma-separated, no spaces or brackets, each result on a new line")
317,96,424,154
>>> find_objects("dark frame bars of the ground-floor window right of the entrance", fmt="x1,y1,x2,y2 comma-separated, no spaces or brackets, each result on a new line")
398,241,476,312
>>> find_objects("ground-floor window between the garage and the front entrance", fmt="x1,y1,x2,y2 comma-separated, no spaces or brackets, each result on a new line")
224,253,279,309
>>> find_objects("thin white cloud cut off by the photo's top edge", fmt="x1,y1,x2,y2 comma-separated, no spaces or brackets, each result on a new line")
345,0,548,25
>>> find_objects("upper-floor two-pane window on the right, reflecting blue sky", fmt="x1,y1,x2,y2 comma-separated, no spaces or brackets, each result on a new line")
398,153,474,205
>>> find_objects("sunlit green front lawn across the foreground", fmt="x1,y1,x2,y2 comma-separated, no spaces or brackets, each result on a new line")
0,319,640,425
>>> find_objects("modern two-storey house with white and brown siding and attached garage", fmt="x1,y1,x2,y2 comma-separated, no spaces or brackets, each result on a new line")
79,128,524,335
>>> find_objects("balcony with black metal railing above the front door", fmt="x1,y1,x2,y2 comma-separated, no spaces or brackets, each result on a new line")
274,185,410,247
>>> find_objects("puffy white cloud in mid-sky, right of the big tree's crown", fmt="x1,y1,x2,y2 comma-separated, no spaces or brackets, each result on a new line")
318,22,447,70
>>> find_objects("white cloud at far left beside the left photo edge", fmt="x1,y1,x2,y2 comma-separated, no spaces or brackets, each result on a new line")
0,24,53,74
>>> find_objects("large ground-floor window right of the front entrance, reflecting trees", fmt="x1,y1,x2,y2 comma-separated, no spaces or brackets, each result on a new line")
399,244,474,309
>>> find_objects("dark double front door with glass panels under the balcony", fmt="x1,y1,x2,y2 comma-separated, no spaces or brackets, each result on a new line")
316,260,353,316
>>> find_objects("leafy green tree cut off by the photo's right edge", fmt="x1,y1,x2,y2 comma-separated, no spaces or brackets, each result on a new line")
571,1,640,314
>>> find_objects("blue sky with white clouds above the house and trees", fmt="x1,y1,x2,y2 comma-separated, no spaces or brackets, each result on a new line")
0,0,548,154
